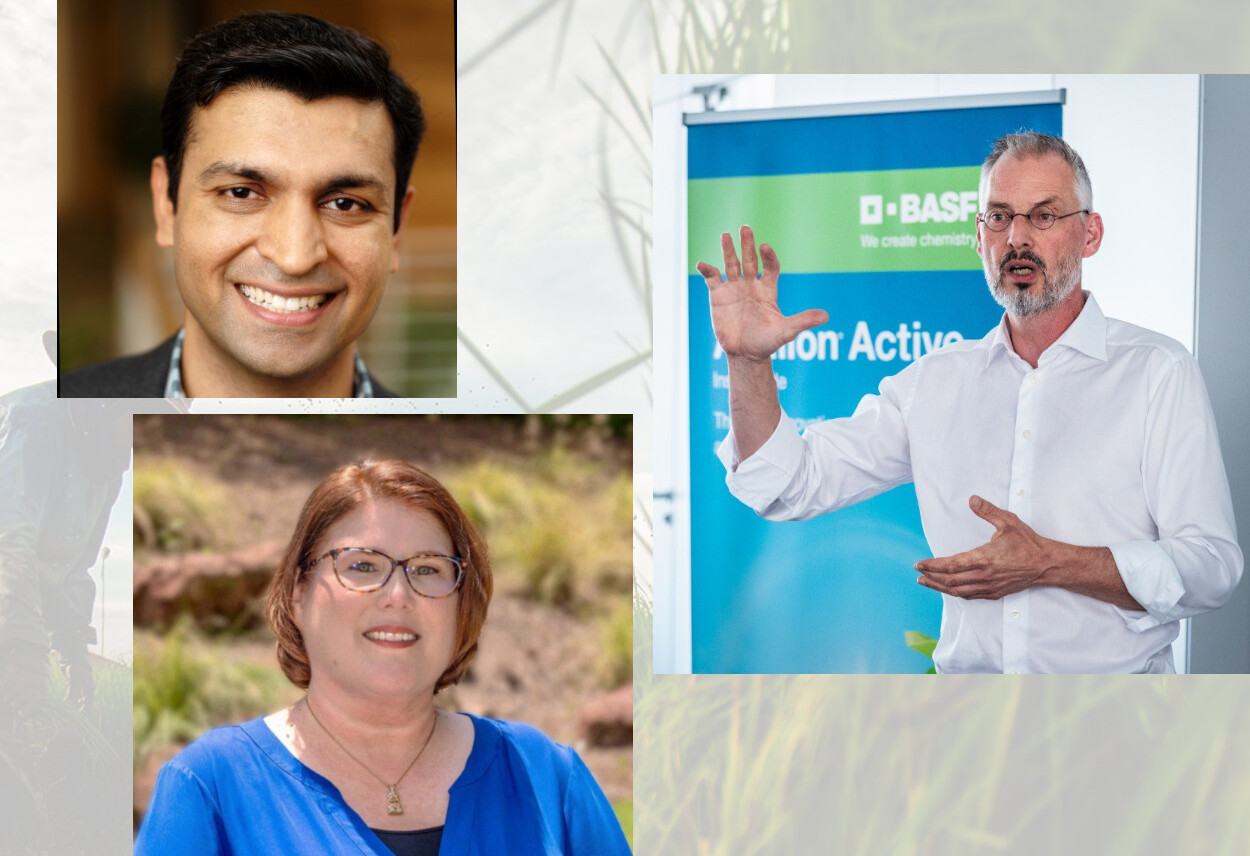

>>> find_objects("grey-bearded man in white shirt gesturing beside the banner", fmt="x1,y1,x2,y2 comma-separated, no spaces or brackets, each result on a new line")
699,132,1243,672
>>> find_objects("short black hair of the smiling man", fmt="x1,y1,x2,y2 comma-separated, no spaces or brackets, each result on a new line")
160,12,425,231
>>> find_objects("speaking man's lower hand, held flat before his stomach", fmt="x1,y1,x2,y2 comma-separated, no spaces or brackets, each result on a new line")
915,496,1058,600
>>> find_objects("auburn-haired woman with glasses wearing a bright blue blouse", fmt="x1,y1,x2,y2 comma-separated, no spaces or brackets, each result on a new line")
135,461,629,856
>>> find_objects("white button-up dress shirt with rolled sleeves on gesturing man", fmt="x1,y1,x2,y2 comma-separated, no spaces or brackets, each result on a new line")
719,296,1243,672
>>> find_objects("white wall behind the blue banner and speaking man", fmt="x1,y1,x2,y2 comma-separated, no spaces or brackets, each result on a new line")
653,75,1199,674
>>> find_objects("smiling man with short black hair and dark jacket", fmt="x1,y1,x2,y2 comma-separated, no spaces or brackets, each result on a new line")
60,12,425,397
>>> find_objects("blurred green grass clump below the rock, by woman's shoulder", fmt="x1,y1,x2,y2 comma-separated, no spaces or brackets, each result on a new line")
134,619,299,769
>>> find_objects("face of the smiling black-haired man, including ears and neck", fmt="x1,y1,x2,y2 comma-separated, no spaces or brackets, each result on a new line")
153,86,413,397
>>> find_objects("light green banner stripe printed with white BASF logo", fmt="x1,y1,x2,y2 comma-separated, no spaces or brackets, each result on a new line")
688,166,981,274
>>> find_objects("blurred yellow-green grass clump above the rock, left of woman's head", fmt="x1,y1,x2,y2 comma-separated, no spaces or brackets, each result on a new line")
134,460,230,552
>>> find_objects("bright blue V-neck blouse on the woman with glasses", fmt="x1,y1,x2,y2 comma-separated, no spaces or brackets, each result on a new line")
135,714,630,856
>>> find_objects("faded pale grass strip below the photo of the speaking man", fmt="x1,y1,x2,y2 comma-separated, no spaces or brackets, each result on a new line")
634,675,1250,856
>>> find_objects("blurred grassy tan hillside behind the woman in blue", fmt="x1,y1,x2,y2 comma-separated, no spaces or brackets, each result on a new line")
133,415,634,839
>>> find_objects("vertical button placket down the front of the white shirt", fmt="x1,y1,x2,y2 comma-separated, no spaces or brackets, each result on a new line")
1003,370,1043,674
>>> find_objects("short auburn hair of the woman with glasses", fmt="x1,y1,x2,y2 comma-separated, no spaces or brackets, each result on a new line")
265,461,493,692
